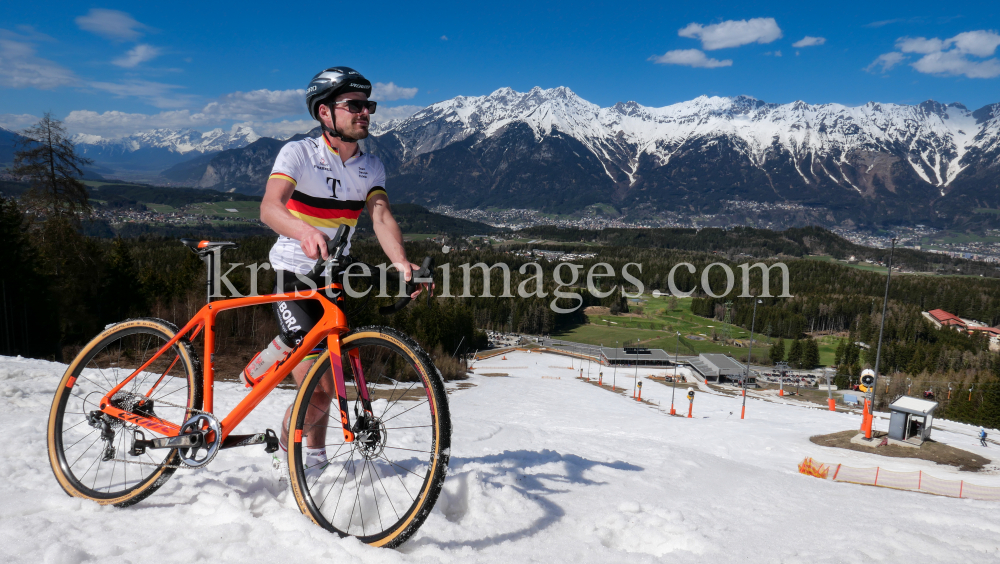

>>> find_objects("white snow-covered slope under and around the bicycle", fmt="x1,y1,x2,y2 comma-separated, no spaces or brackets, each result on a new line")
0,353,1000,564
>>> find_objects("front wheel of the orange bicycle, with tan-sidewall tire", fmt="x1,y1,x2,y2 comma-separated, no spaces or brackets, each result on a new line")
288,326,451,548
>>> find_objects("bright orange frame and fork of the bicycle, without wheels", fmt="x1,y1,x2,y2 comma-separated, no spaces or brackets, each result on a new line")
94,283,371,448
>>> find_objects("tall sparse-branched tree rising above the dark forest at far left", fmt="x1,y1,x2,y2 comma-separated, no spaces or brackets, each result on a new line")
10,112,92,223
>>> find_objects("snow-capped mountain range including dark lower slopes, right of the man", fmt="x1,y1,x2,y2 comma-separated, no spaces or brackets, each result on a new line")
358,87,1000,221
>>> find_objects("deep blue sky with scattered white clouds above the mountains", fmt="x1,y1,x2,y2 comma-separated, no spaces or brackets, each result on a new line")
0,0,1000,136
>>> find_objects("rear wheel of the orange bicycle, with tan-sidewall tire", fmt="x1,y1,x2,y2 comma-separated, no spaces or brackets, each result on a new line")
47,318,202,507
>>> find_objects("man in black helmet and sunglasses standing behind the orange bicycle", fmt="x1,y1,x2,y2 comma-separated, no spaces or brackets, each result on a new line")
258,67,423,476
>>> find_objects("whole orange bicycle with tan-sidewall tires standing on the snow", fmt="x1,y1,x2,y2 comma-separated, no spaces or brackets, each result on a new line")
48,228,451,547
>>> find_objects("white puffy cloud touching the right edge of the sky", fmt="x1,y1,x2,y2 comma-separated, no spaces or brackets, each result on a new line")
884,29,1000,78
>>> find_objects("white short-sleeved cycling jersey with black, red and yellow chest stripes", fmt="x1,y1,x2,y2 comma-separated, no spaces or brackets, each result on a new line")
270,136,386,274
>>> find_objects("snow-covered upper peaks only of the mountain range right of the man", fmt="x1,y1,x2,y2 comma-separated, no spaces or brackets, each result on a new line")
375,87,1000,195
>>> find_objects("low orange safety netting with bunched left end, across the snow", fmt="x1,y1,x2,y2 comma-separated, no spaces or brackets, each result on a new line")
799,458,1000,501
